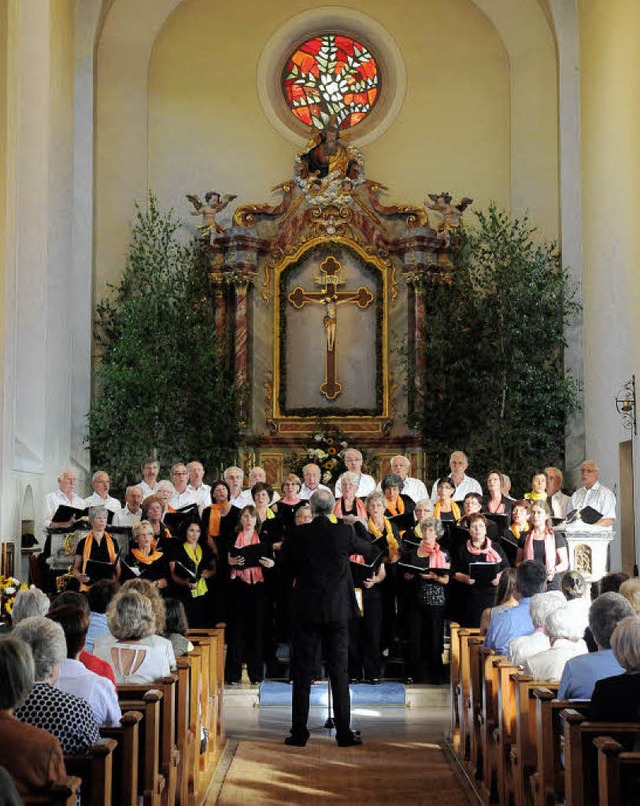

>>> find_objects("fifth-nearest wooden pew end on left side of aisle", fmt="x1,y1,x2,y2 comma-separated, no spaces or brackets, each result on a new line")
117,674,180,805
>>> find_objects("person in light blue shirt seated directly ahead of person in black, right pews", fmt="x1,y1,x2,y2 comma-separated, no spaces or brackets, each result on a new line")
558,593,633,700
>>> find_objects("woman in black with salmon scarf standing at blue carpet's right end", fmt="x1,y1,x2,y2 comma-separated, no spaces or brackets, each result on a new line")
400,518,451,683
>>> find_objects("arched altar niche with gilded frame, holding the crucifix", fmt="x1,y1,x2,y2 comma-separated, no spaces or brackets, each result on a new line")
269,237,390,434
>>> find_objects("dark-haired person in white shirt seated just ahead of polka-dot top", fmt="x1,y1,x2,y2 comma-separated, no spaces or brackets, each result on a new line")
49,605,122,725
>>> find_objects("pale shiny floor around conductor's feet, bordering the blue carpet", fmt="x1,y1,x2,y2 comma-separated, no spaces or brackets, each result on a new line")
225,684,450,743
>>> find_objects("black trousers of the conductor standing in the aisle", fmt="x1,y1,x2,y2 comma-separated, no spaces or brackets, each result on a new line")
291,619,351,740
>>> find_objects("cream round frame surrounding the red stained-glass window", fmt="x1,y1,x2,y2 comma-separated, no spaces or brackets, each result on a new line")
257,6,407,147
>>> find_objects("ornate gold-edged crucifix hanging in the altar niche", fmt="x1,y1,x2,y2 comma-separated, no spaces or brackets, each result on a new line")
288,257,374,400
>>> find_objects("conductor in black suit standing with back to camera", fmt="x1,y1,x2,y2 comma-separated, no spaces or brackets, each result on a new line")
280,490,377,747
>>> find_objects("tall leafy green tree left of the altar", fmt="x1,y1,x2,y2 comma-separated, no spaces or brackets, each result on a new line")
89,194,239,496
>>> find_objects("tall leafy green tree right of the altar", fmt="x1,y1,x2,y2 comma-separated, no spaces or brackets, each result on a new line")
416,205,579,490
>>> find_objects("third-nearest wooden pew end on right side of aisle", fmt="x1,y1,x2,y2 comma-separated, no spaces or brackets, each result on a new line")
530,683,589,806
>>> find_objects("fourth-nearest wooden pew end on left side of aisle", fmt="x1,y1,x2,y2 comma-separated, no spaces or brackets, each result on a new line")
119,688,166,806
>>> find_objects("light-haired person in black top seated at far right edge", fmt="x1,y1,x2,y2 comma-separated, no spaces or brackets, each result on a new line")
587,614,640,722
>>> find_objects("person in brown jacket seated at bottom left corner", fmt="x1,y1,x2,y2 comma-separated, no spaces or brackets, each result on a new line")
0,635,67,802
